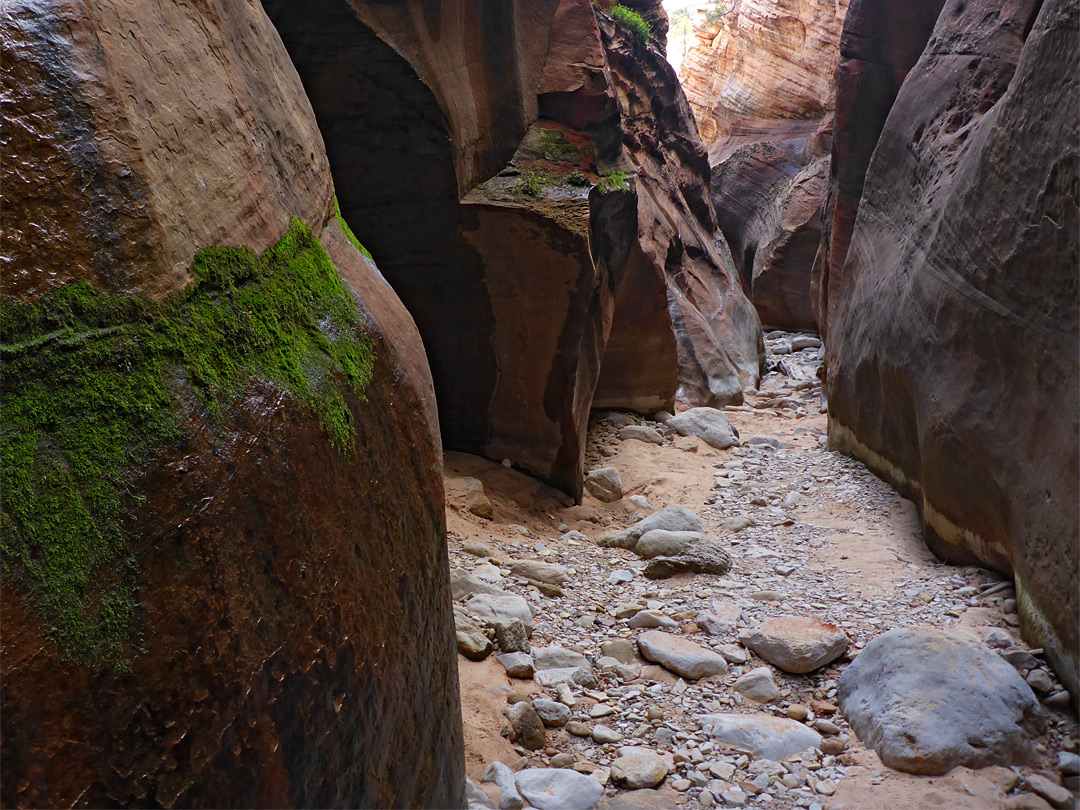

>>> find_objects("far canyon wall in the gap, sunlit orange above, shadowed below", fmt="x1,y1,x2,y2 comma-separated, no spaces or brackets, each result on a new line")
681,0,848,329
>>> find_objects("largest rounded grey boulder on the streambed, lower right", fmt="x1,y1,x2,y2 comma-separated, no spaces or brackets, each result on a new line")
837,627,1043,774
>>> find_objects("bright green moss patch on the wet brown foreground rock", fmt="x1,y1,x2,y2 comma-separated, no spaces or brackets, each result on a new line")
0,219,374,665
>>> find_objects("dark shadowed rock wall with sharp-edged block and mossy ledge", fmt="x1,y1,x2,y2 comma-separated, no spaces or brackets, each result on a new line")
264,0,612,499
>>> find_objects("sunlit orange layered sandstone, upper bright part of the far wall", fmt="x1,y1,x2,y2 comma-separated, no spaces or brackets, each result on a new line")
681,0,848,158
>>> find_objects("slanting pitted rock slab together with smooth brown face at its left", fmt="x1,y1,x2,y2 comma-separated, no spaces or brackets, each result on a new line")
594,9,764,411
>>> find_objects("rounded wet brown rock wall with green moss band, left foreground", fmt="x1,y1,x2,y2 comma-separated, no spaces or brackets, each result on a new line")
0,0,463,807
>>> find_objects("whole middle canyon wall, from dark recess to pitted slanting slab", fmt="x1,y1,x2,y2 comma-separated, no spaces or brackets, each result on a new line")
264,0,758,499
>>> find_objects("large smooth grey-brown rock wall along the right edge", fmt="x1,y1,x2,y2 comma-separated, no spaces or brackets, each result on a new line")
826,0,1080,699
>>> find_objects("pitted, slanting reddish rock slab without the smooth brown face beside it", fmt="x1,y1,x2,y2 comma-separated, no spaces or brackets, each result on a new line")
597,9,765,406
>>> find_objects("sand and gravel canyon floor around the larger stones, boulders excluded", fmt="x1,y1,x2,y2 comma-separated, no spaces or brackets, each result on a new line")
445,334,1078,810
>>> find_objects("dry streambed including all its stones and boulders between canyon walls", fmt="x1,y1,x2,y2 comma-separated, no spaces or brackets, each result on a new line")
446,334,1078,810
